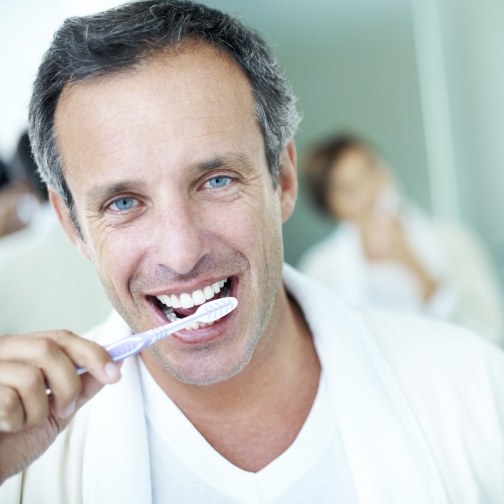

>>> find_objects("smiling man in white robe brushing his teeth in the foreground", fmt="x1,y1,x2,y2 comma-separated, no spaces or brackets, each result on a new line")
0,1,504,503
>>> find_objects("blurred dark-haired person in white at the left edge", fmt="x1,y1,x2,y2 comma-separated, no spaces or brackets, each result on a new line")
0,132,111,334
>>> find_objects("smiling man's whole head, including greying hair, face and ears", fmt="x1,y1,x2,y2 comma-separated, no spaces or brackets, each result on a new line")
31,2,297,384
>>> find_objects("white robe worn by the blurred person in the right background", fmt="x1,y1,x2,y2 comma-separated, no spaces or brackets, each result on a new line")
298,207,504,346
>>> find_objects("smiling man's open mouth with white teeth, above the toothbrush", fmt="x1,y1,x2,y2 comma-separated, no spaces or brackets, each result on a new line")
156,278,231,330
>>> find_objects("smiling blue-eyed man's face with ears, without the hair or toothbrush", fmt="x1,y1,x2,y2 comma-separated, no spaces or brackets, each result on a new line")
52,45,295,384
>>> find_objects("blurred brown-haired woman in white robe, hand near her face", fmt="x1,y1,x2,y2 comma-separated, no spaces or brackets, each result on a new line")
298,134,504,345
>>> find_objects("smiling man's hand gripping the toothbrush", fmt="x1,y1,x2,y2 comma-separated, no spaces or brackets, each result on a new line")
0,331,120,484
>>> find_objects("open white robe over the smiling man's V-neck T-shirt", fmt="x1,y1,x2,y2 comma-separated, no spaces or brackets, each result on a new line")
0,266,504,504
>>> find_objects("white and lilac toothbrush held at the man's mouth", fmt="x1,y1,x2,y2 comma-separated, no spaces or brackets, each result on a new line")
77,297,238,374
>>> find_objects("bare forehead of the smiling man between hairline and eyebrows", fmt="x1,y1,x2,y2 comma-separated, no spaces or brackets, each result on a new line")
55,43,262,183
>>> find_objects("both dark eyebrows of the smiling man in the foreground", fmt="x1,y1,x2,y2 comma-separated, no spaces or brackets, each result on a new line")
86,153,256,208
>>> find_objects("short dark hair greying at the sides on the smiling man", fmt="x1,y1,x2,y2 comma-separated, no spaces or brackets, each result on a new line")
29,0,300,215
